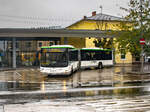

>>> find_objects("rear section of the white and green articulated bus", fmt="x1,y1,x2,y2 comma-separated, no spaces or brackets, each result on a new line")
80,48,114,69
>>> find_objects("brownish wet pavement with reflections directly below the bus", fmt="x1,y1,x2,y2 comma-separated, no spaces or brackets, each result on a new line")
0,66,150,91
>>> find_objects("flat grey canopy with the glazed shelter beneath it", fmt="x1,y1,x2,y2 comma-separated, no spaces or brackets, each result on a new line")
0,28,108,68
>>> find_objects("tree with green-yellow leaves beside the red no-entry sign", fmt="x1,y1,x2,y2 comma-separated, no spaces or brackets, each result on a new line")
116,0,150,60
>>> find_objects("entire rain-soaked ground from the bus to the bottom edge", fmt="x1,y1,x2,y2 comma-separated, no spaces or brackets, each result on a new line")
0,64,150,112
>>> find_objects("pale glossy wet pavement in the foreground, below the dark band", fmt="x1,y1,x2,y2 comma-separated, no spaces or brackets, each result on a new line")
2,91,150,112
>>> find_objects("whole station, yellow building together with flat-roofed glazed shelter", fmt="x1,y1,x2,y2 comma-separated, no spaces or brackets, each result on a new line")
0,12,132,67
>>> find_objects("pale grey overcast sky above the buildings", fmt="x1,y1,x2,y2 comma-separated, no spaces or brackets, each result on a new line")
0,0,129,28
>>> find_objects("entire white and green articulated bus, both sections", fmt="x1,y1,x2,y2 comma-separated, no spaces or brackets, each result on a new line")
40,45,113,75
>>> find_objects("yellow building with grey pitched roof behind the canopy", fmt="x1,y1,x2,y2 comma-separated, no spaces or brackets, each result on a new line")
61,12,132,63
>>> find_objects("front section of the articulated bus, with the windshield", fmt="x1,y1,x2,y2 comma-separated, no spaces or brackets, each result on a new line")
40,45,79,75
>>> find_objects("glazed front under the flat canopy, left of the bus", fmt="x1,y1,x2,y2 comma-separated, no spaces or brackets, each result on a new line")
0,37,60,67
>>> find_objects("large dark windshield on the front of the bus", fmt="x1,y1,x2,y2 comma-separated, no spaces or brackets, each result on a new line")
41,49,68,67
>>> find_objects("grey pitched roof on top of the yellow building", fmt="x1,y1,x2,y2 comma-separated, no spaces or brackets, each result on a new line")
85,13,125,21
